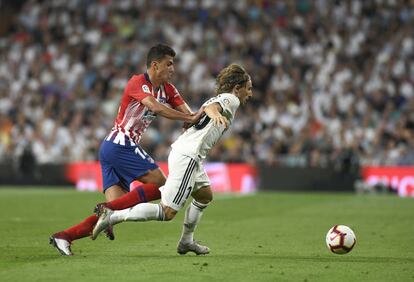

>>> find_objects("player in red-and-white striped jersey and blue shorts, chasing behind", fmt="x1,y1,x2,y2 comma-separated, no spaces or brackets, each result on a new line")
50,44,201,255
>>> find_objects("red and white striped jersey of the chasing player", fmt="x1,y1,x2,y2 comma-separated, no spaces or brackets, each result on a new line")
106,73,184,146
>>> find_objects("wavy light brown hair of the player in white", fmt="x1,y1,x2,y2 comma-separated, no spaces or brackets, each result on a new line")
216,64,250,94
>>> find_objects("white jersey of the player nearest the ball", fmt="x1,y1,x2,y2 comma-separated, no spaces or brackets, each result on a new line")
171,93,240,159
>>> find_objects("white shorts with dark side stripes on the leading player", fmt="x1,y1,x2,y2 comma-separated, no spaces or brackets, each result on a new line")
160,149,210,211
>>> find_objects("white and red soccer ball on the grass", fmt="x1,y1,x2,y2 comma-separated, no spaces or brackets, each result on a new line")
326,225,356,255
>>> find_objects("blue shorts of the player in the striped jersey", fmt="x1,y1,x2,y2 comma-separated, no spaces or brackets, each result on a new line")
99,140,158,192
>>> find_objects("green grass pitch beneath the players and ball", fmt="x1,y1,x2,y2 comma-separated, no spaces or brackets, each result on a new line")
0,188,414,282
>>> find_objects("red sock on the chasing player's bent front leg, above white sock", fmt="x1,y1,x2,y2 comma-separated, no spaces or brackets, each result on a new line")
106,183,161,210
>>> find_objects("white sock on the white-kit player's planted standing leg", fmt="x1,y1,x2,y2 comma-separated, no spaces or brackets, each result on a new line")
180,200,208,243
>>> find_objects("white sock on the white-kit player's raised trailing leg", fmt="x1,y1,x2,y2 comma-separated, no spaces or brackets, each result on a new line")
109,203,164,225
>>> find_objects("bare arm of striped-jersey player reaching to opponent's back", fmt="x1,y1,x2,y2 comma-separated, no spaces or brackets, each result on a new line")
141,96,201,123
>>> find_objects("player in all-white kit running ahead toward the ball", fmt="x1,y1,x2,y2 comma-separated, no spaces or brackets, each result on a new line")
92,64,252,255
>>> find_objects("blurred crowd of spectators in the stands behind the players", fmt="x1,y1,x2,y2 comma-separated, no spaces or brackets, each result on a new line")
0,0,414,173
